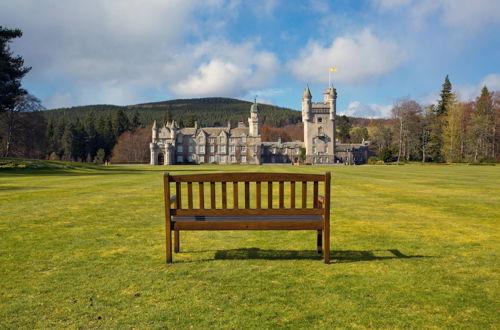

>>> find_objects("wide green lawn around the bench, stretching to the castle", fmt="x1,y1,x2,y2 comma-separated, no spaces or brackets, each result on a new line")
0,165,500,329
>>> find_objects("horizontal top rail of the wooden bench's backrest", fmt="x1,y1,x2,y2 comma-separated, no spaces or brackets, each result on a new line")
171,172,325,182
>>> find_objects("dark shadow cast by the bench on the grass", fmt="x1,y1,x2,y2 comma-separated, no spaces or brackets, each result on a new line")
215,248,433,263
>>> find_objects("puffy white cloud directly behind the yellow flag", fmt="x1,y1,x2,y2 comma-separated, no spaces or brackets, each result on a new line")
289,29,405,83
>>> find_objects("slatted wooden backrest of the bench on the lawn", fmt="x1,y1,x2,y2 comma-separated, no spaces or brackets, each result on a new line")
164,172,330,216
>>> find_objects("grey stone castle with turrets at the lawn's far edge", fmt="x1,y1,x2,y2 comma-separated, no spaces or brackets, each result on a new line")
150,87,368,165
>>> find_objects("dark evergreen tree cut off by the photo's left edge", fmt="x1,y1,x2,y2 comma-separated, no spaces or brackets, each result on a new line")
0,26,31,113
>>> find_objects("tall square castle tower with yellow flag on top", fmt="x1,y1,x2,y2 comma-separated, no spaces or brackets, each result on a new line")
302,88,337,164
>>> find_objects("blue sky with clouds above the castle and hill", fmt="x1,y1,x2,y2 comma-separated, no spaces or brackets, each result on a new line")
0,0,500,118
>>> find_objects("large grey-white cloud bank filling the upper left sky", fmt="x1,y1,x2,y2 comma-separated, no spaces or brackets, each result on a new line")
0,0,279,107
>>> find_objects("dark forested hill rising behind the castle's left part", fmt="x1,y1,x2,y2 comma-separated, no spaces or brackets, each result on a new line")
43,97,301,126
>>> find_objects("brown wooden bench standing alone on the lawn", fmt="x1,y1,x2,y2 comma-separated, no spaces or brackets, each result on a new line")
164,172,330,263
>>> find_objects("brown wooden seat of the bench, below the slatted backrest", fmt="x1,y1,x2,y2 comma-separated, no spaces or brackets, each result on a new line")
172,215,323,230
